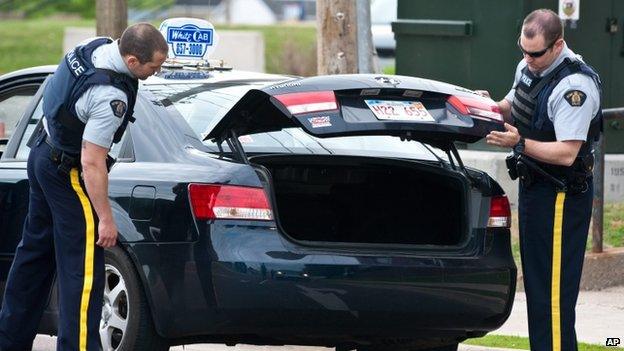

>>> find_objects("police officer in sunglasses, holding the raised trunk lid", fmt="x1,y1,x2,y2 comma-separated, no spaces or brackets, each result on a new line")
486,9,602,351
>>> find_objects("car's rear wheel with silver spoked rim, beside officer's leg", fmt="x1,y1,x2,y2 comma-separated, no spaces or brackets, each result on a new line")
100,247,169,351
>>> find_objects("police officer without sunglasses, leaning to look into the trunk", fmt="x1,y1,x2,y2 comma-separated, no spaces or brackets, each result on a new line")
0,23,168,350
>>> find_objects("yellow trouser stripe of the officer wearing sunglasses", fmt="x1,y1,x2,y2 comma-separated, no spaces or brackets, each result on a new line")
550,191,565,351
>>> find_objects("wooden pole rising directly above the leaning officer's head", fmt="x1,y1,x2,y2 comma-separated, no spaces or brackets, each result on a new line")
95,0,128,39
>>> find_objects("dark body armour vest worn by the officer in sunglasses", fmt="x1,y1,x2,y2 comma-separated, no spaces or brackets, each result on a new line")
511,58,602,178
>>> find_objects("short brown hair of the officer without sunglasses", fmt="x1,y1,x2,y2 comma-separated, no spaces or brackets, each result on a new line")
119,22,169,64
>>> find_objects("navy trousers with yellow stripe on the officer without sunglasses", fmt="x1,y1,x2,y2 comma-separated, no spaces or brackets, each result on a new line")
0,138,104,350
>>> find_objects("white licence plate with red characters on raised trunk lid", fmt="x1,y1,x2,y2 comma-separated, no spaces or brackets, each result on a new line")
364,100,434,122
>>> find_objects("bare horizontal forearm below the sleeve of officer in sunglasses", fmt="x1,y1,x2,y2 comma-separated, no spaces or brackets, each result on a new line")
524,139,583,166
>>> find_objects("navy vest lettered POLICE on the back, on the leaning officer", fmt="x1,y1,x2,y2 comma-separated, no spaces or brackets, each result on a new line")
43,38,138,155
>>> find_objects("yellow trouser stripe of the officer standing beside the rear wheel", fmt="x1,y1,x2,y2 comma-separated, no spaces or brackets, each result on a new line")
70,168,95,351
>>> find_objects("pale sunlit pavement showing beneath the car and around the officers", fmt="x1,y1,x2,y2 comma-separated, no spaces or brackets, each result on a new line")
33,286,624,351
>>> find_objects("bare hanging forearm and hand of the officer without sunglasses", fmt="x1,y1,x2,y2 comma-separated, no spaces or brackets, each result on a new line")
80,140,117,247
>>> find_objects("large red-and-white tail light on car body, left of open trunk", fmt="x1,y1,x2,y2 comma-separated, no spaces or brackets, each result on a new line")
189,184,273,221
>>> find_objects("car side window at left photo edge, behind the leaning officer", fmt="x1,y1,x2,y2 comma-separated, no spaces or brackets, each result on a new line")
0,86,38,152
